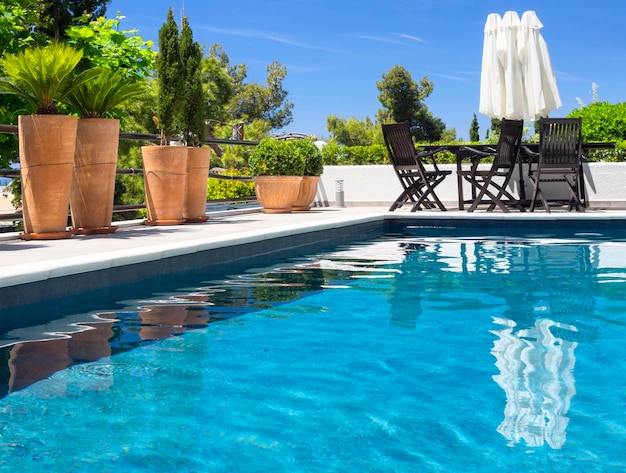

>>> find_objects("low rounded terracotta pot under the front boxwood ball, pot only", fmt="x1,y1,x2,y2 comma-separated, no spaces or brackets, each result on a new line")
254,176,302,214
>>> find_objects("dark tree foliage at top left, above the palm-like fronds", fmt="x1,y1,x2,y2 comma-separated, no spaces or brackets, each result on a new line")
35,0,111,41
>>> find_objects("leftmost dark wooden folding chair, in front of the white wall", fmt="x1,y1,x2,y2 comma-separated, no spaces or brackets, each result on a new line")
382,122,452,212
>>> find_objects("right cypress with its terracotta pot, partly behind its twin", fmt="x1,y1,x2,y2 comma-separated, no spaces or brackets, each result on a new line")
180,17,211,223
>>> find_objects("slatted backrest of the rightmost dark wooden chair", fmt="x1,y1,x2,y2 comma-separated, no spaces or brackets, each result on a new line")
539,118,582,170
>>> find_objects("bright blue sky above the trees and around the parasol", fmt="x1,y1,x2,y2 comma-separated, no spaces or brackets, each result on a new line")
107,0,626,140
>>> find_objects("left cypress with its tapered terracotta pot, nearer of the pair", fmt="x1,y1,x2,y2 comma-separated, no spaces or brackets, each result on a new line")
141,8,187,225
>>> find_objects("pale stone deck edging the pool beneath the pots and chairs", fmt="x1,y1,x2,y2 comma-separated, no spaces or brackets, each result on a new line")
0,206,626,310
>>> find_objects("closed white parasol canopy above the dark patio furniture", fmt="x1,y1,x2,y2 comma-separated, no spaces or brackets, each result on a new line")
479,11,561,121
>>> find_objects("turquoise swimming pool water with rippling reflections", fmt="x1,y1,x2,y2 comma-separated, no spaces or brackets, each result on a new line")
0,229,626,472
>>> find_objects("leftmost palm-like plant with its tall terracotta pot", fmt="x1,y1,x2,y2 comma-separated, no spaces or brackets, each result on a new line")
0,42,82,240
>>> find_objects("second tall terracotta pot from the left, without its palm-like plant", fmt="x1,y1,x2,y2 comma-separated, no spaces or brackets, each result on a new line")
70,118,120,234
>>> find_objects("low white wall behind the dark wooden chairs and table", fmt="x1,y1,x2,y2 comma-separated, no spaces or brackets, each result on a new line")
316,163,626,209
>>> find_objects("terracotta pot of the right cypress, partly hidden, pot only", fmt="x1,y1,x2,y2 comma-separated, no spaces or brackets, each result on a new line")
183,147,211,223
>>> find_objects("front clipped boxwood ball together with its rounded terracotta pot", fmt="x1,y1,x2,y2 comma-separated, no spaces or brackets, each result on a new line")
248,138,305,213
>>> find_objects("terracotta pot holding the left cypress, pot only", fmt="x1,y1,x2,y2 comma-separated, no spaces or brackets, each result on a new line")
141,146,188,225
